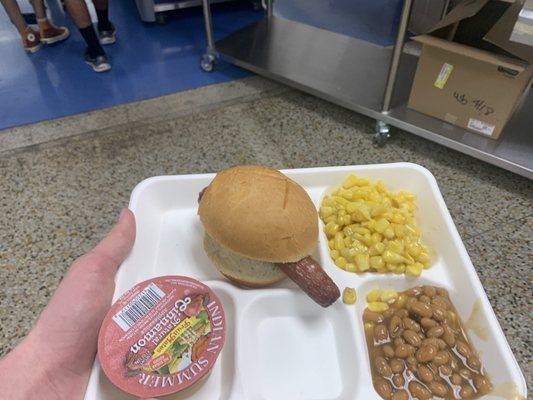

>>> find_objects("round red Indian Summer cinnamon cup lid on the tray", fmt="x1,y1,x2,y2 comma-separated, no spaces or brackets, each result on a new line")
98,276,226,397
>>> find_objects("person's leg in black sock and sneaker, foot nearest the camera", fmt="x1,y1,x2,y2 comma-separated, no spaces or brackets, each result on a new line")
65,0,111,72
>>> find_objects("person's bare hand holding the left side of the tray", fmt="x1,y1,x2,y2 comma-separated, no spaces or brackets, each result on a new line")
0,209,135,400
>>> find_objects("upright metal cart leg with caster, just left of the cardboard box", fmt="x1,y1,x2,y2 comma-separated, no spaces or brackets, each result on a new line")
374,0,413,146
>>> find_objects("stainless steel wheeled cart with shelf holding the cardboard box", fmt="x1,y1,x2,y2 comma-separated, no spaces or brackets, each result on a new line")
201,0,533,179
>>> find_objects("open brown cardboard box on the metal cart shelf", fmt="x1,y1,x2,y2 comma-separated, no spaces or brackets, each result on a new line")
408,0,533,139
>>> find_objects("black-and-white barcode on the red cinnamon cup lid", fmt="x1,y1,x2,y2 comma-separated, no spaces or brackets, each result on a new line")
113,283,165,332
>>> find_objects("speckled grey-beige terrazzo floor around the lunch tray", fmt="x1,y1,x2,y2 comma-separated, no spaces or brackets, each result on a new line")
0,79,533,386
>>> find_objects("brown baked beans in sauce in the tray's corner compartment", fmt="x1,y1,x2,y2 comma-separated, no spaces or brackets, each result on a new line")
363,285,492,400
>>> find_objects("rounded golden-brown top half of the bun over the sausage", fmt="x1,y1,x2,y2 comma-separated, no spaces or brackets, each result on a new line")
198,166,318,262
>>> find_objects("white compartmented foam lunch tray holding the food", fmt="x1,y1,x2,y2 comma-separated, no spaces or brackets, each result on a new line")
85,163,527,400
